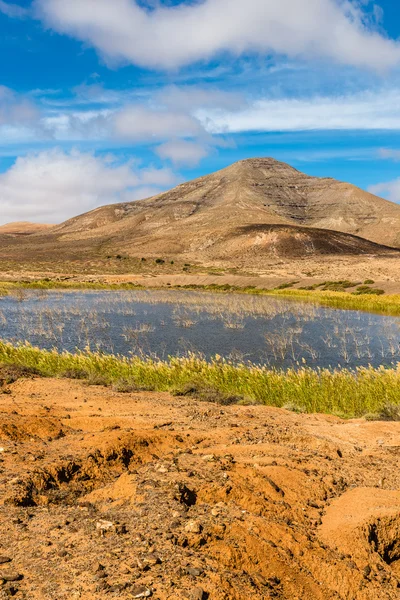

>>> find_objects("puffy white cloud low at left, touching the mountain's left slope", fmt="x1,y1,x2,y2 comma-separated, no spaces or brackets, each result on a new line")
0,149,177,223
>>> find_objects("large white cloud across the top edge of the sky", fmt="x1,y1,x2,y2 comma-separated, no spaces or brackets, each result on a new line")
35,0,400,69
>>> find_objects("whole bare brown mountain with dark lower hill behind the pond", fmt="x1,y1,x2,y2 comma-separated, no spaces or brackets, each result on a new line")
1,158,400,267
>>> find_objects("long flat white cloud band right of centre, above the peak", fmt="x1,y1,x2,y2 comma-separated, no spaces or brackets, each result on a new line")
200,89,400,134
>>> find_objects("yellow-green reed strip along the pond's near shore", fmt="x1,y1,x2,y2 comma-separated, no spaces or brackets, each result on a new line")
0,342,400,417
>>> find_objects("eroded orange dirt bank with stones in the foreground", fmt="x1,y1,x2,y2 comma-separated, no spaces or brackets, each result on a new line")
0,378,400,600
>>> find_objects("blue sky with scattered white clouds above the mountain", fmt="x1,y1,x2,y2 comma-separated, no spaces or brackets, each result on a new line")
0,0,400,224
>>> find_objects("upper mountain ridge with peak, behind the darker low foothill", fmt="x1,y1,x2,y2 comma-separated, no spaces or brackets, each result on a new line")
55,158,400,247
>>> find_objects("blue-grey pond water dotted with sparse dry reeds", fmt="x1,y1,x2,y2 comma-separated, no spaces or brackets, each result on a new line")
0,290,400,368
